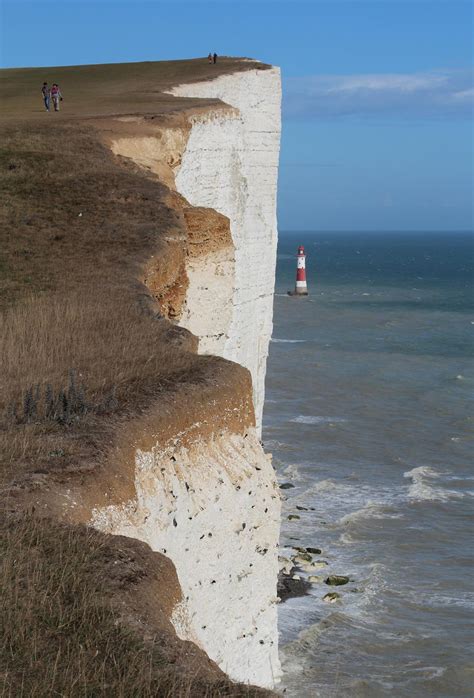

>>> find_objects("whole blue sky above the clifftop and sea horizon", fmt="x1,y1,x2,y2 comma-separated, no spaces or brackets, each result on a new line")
1,0,473,230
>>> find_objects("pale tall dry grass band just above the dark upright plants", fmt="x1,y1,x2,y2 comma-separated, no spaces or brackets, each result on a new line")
0,294,186,408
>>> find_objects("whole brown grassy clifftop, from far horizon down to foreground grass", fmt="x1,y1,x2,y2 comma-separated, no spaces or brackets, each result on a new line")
0,59,274,697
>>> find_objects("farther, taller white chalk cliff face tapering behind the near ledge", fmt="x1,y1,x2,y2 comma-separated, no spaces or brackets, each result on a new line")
169,68,281,432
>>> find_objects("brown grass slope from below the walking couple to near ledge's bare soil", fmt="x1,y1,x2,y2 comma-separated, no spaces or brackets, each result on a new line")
0,121,213,481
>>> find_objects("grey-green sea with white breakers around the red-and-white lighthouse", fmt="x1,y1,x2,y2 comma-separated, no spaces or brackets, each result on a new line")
263,232,474,698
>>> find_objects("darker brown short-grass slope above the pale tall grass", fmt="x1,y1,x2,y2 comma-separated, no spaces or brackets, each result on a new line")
0,124,179,307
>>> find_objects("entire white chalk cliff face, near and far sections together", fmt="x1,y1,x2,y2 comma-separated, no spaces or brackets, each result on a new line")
92,69,280,687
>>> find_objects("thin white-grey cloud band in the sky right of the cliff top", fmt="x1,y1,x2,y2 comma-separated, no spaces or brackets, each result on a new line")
283,70,474,118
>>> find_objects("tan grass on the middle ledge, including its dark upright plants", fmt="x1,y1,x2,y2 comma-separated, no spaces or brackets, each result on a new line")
0,294,212,482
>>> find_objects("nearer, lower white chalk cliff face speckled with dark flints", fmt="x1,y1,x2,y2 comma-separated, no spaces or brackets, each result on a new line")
94,429,280,686
